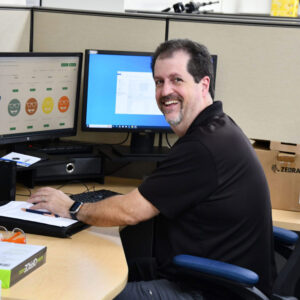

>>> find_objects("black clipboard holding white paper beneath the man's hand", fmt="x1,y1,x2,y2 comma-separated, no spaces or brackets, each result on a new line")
0,201,90,238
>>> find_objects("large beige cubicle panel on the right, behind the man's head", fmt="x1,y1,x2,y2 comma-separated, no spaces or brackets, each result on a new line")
169,18,300,143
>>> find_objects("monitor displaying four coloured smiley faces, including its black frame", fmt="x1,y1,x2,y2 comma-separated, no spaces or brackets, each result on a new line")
0,52,82,144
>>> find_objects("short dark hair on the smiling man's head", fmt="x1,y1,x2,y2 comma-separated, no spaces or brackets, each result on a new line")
151,39,215,98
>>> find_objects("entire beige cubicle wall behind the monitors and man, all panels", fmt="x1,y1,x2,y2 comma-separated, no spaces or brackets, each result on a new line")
0,8,300,143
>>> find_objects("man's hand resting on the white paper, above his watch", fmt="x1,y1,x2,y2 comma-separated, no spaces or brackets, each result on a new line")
27,187,74,218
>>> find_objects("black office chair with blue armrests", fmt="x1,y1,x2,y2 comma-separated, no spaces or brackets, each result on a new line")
173,226,300,300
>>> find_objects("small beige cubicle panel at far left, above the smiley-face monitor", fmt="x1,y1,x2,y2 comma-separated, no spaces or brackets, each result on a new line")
0,8,31,52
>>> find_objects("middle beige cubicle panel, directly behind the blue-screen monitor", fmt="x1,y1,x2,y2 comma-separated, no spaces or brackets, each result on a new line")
33,10,165,143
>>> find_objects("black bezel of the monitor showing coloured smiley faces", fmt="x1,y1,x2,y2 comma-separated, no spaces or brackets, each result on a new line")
0,52,83,145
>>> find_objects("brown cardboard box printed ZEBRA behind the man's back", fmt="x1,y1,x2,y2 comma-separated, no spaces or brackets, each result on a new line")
253,142,300,211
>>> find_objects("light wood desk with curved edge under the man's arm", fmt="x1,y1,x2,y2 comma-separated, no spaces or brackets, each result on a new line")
2,178,139,300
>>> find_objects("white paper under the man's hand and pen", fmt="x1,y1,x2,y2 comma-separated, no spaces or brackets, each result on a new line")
0,201,77,227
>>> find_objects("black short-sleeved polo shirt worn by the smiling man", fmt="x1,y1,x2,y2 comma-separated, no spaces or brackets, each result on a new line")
139,101,274,294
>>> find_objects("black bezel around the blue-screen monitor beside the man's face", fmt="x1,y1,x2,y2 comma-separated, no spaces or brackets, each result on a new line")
81,49,173,133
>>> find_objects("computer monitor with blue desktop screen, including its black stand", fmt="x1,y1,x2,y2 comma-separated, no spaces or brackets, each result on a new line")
82,49,216,156
